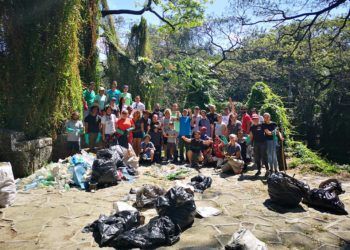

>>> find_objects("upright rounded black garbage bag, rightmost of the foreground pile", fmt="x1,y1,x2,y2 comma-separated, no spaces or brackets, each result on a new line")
156,187,196,230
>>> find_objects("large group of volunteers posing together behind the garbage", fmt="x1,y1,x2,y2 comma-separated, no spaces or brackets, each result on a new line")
66,81,284,175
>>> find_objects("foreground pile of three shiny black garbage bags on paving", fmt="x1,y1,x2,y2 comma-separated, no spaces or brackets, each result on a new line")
83,187,196,249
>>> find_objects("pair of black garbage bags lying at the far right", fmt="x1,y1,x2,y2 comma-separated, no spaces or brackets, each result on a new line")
267,173,348,214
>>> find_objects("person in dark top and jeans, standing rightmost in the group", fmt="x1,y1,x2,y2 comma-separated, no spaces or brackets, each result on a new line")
262,113,283,173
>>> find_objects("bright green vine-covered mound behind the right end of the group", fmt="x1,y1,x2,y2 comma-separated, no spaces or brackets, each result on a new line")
247,82,291,139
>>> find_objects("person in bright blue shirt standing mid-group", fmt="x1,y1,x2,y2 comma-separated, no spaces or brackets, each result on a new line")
178,109,192,162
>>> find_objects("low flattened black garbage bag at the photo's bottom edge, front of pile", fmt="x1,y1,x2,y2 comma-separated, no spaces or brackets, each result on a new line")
112,216,181,249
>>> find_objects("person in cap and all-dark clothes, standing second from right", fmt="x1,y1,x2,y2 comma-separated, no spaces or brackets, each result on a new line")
249,114,269,176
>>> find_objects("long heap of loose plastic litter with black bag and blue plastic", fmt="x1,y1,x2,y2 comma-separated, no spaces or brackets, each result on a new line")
16,145,138,191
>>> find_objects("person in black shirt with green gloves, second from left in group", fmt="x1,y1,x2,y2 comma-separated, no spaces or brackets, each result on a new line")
84,106,102,148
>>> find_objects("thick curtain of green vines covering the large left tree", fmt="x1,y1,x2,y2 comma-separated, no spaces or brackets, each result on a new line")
0,0,82,138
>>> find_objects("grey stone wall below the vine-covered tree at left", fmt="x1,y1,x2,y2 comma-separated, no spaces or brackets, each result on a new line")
0,129,52,178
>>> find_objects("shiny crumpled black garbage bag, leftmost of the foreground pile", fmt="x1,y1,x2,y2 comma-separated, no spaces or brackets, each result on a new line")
82,211,143,247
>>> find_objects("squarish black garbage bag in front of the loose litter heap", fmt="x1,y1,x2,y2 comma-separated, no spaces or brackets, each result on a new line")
91,159,118,185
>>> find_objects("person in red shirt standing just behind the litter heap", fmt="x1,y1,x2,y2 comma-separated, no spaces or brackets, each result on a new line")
116,110,135,148
